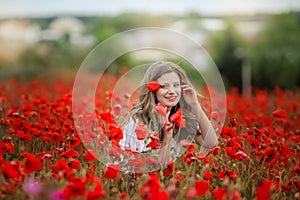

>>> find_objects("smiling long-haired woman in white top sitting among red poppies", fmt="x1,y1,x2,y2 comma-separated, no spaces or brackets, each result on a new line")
120,61,218,163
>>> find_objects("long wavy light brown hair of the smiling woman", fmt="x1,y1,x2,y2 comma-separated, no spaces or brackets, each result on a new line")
127,61,199,140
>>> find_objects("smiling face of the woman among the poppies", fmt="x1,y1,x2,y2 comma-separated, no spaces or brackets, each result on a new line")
155,72,181,109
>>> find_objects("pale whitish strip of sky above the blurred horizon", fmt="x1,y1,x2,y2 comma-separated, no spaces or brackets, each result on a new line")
0,0,300,18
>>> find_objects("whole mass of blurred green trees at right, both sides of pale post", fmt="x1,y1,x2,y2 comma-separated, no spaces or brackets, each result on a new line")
209,13,300,90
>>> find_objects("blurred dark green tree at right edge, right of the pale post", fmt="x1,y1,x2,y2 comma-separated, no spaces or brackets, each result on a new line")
247,13,300,88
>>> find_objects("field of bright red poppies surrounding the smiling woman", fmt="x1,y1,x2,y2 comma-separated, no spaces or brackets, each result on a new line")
0,75,300,200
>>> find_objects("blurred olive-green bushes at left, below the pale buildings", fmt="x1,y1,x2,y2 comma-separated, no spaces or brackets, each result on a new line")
10,40,87,79
